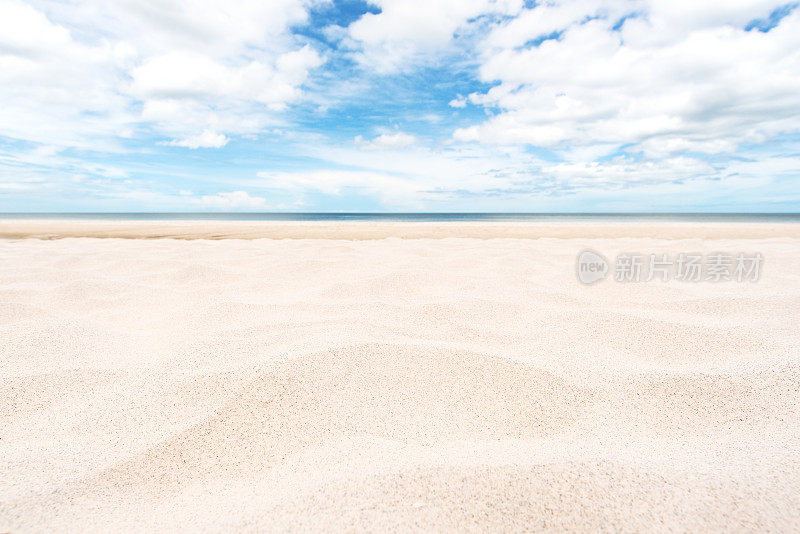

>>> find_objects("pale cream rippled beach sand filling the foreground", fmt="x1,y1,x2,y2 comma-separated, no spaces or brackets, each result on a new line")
0,221,800,532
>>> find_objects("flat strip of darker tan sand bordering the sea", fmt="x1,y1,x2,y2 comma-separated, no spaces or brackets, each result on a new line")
0,219,800,241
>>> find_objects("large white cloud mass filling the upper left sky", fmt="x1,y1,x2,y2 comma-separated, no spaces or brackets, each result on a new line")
0,0,322,151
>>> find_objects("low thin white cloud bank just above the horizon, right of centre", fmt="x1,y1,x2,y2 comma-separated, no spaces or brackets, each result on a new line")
260,131,800,211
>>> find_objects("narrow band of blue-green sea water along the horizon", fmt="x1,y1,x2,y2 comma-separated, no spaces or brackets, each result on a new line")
0,213,800,222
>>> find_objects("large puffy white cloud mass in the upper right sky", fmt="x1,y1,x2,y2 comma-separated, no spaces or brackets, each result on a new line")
454,0,800,158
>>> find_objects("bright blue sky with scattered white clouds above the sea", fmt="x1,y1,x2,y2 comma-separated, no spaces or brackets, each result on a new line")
0,0,800,212
